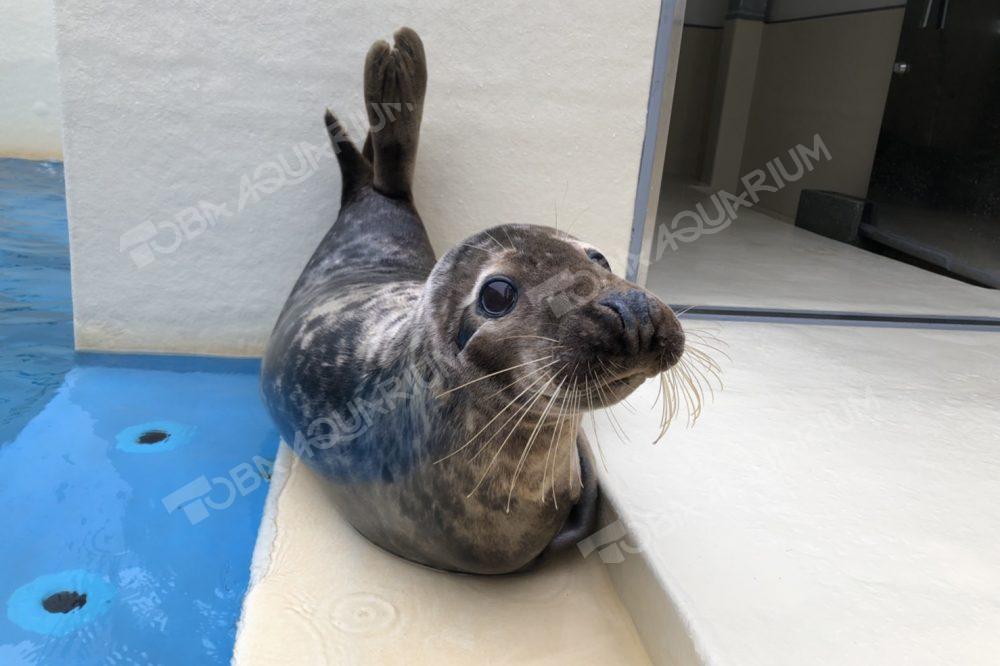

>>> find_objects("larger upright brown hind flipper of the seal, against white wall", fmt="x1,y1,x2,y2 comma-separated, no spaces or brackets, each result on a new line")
365,28,427,199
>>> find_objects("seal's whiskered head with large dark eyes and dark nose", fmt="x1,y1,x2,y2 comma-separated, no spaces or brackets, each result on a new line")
422,225,684,408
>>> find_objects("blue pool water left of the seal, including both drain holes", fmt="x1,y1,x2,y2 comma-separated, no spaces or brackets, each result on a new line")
0,160,278,666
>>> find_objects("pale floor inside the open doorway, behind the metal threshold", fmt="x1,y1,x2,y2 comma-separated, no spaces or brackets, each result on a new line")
647,180,1000,317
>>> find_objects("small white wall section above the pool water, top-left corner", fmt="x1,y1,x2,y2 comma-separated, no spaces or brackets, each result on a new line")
0,0,62,160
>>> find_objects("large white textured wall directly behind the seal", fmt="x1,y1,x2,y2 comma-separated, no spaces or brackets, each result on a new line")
58,0,660,355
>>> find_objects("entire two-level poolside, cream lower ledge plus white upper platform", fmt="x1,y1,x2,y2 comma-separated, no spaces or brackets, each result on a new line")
235,321,1000,666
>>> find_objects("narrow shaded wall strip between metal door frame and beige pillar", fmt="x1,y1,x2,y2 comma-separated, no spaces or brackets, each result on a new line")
665,26,722,179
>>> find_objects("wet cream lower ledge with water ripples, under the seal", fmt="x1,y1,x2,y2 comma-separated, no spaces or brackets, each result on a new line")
233,445,650,665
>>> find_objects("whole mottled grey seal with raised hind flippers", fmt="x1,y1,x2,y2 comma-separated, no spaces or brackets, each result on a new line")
262,28,683,573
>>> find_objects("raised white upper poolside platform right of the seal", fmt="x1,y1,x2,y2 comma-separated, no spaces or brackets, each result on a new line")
588,321,1000,666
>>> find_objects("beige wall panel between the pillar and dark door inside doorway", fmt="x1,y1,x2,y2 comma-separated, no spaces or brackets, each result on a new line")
742,8,903,216
